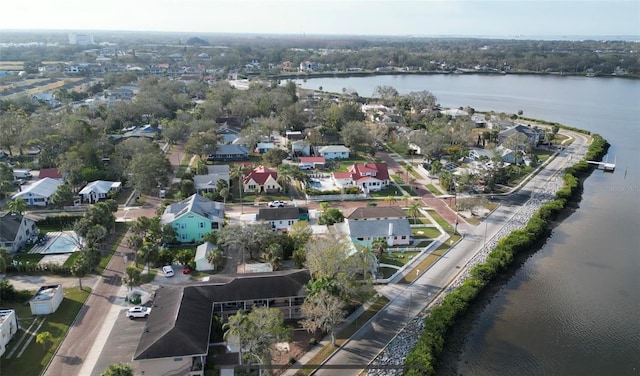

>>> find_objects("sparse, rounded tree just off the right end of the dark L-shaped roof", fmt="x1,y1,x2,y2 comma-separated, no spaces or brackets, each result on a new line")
301,290,347,347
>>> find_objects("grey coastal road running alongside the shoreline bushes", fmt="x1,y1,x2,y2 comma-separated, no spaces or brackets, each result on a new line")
313,132,587,376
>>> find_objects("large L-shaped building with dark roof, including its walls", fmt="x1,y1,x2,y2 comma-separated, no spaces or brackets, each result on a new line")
133,270,311,376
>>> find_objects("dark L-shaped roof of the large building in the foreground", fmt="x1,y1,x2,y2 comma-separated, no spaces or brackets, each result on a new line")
133,270,311,360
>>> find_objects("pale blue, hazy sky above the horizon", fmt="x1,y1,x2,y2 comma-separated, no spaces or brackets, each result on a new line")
0,0,640,40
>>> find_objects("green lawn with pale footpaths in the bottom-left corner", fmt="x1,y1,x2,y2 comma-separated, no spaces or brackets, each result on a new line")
2,287,91,376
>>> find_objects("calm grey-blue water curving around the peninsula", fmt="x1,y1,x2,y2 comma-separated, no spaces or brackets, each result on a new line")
297,75,640,376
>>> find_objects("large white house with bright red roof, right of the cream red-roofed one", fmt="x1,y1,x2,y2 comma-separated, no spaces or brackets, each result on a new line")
333,163,390,193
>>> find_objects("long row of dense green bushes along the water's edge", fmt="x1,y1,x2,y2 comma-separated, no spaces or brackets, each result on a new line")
405,134,609,376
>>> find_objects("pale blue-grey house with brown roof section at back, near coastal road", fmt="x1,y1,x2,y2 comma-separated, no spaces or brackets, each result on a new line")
345,206,411,246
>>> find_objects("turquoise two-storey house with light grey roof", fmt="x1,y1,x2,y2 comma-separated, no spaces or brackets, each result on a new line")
160,193,224,243
